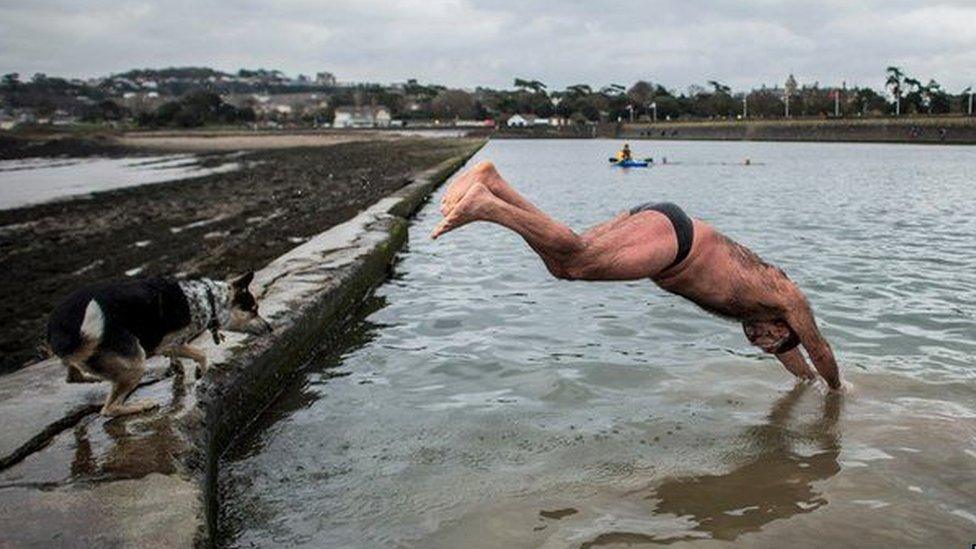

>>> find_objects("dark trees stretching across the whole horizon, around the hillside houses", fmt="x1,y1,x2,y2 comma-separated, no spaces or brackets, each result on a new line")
0,66,972,127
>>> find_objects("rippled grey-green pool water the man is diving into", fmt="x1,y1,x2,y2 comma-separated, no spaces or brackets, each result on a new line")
221,141,976,547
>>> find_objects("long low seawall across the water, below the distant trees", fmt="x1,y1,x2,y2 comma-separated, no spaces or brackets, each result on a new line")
620,117,976,145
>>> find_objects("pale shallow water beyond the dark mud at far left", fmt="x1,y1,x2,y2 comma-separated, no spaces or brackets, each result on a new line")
0,154,240,209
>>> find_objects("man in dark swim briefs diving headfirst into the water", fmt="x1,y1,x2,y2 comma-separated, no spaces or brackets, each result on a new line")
431,162,841,389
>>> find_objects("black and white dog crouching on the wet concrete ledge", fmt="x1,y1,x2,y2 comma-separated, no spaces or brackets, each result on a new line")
47,273,271,417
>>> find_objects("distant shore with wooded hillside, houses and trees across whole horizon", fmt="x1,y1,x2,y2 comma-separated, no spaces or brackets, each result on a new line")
0,67,973,129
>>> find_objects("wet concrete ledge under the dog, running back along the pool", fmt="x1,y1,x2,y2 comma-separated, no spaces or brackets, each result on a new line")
0,140,477,547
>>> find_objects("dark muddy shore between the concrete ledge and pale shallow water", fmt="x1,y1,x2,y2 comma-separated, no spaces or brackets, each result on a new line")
0,138,476,374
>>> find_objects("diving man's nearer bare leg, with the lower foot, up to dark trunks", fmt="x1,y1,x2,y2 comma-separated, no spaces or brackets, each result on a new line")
431,182,677,280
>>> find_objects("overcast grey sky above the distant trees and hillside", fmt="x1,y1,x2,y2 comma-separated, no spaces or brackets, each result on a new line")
0,0,976,91
